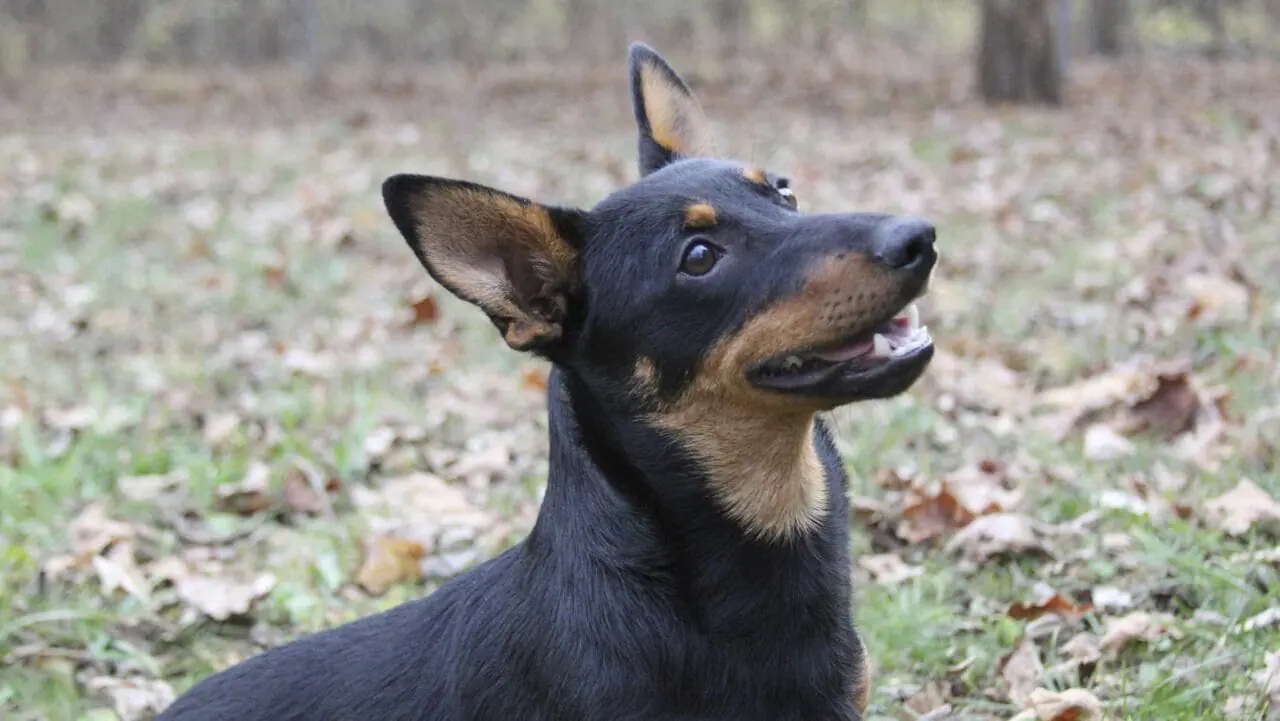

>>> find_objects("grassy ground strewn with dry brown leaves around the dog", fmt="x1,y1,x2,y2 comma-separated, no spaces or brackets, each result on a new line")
0,48,1280,721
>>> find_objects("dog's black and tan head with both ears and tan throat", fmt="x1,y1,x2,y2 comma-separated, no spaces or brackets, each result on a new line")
383,45,937,542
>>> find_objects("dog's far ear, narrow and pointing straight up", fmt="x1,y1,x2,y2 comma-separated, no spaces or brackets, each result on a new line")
627,42,716,177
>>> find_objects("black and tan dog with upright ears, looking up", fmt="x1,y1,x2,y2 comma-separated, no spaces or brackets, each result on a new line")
161,45,936,721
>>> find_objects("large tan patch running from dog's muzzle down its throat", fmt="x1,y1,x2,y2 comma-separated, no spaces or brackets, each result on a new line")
640,254,893,539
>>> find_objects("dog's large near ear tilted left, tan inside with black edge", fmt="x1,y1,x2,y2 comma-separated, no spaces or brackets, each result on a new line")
383,175,584,351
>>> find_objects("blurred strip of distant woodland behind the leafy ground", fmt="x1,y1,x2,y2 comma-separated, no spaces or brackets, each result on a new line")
0,0,1280,102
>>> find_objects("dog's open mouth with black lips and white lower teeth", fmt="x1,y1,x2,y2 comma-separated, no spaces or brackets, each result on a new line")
748,302,933,398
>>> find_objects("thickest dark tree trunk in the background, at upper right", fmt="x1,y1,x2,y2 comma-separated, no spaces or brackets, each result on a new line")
978,0,1062,105
